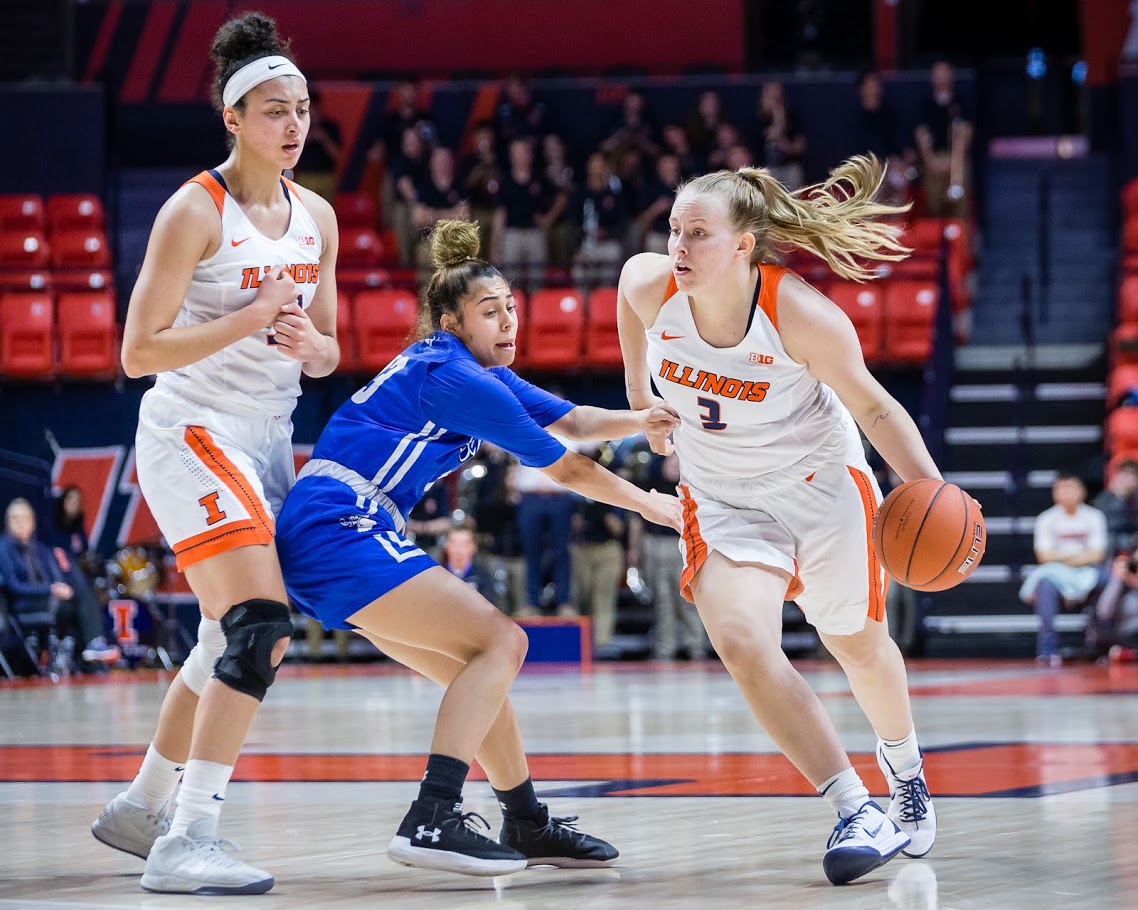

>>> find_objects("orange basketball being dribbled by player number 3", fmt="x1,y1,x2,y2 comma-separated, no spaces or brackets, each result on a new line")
873,478,988,590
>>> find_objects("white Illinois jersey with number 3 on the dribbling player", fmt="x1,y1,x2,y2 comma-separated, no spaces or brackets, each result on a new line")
648,264,864,493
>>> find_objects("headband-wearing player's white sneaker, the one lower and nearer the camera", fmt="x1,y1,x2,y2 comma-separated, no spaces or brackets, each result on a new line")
142,818,274,894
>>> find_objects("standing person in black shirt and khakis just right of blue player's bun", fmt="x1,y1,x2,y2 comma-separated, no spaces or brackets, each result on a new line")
494,138,568,290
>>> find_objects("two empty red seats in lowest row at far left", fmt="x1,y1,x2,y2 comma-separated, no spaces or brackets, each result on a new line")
0,290,119,379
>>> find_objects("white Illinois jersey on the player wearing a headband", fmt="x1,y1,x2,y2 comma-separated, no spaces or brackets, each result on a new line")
155,171,323,416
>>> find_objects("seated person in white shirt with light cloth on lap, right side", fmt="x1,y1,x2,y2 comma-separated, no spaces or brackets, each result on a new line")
1020,474,1107,667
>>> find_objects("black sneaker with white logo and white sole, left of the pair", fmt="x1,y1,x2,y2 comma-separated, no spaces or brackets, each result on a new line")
387,799,528,875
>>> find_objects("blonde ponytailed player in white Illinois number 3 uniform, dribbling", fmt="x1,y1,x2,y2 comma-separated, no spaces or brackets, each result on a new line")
619,157,940,884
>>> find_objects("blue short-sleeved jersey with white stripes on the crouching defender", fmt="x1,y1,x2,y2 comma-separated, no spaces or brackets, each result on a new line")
302,332,575,518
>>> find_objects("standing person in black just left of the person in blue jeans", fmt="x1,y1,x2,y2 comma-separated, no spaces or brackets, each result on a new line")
472,441,526,617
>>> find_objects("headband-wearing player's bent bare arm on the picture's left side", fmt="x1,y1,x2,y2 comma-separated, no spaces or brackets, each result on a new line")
121,184,296,379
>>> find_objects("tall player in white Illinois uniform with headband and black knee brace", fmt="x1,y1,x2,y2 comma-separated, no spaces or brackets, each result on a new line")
91,13,339,894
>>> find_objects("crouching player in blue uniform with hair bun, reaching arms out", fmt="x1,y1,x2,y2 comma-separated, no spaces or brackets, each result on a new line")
277,221,681,875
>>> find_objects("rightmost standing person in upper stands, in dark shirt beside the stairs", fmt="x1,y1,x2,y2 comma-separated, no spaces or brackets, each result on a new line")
916,60,972,218
